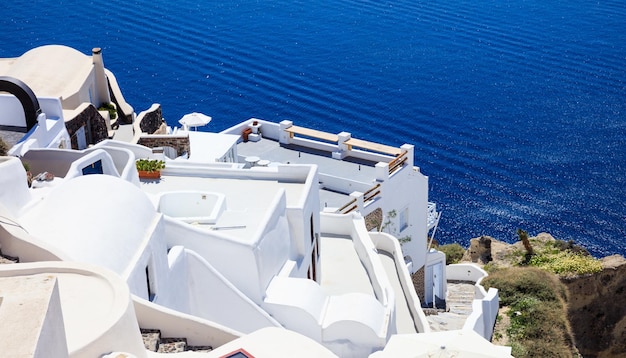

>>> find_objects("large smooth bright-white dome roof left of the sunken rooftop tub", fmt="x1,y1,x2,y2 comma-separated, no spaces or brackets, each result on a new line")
21,175,158,274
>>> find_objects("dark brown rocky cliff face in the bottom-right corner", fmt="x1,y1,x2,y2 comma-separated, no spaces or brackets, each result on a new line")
561,255,626,358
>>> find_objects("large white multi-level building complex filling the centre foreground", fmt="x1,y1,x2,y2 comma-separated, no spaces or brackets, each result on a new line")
0,44,510,357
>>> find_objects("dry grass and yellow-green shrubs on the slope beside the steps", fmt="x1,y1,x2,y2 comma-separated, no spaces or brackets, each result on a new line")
468,234,602,358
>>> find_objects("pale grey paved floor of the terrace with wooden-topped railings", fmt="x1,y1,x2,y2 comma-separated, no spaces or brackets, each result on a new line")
237,138,376,208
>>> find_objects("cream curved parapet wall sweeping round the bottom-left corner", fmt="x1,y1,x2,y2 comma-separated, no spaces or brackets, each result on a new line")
0,262,147,357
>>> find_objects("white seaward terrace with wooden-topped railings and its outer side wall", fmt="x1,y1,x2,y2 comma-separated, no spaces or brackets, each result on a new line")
222,118,439,273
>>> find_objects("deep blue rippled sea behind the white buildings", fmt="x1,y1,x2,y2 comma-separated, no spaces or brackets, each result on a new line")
0,0,626,256
